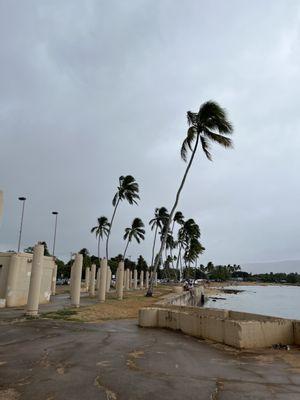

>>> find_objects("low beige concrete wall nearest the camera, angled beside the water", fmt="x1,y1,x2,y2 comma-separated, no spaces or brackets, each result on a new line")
139,307,300,349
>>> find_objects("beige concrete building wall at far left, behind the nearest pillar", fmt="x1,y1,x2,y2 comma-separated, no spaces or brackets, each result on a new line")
0,253,55,307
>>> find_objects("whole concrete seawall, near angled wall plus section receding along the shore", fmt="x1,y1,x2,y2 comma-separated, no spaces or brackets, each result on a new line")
139,288,300,349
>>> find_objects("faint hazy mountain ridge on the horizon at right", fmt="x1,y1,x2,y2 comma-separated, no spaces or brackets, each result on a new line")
240,260,300,274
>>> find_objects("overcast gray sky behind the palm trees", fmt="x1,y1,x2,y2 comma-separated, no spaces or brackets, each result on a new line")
0,0,300,263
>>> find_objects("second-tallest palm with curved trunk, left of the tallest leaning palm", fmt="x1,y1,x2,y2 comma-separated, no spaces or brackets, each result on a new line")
106,175,140,260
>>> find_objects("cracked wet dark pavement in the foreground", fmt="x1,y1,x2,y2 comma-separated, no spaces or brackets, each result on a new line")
0,320,300,400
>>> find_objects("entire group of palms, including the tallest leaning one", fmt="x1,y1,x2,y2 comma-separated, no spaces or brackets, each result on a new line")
92,101,233,296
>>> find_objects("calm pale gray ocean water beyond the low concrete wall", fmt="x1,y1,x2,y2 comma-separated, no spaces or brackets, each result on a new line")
204,286,300,320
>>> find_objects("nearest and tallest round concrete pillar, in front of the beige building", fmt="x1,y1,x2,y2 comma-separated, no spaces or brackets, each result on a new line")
26,244,44,315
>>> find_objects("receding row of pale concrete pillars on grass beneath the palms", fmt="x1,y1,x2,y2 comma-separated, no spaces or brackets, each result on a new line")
71,254,157,307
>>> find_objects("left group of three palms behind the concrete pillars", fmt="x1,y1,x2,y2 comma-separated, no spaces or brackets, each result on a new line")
91,175,145,261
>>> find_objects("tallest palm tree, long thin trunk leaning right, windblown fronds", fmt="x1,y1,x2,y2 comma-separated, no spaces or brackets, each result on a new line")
147,101,233,296
